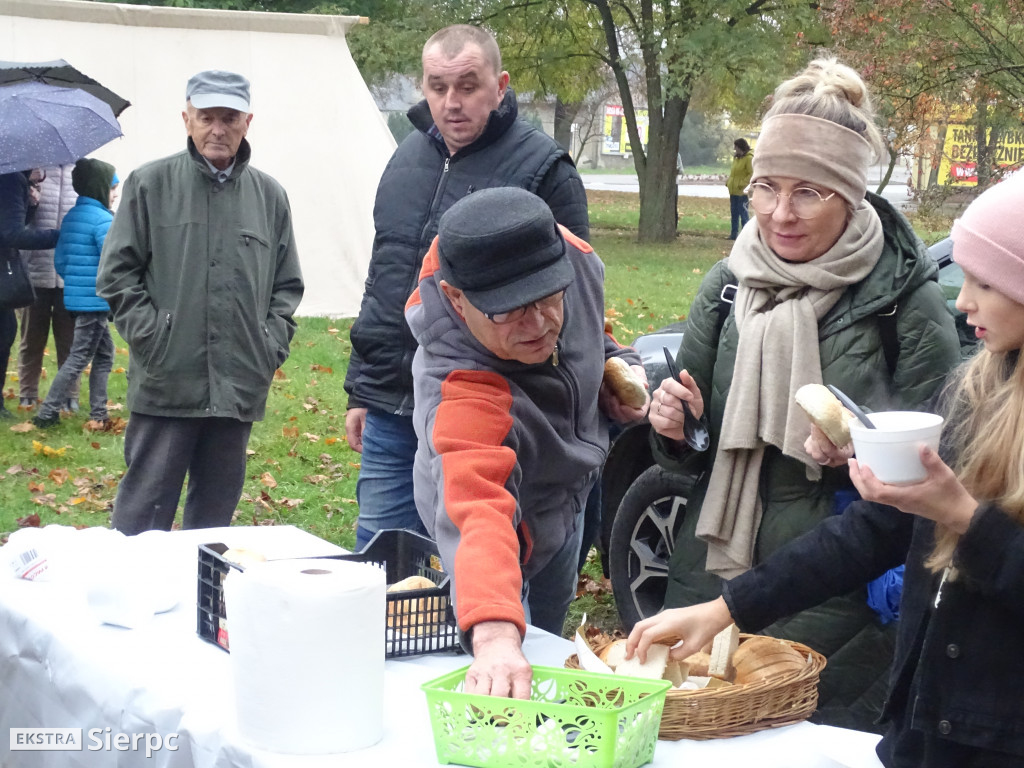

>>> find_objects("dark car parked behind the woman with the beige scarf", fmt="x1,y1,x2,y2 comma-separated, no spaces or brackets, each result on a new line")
600,238,976,630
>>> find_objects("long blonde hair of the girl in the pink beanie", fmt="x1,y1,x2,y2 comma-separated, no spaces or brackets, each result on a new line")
925,349,1024,571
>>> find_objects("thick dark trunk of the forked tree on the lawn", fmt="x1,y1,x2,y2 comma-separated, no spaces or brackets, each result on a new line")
638,96,689,243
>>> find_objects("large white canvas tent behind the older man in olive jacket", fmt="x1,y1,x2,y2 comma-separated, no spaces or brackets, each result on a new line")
0,0,394,316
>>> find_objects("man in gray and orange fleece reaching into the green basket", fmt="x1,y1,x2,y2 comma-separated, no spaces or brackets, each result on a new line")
406,187,649,697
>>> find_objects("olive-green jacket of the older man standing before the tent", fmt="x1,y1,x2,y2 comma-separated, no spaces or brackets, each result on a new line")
96,139,302,421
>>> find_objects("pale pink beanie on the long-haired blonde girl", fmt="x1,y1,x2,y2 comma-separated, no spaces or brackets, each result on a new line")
951,173,1024,304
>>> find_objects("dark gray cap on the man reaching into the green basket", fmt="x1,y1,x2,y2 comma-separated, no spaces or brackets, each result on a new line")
437,186,575,314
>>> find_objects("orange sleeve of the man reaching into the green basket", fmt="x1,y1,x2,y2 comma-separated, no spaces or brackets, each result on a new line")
431,371,526,633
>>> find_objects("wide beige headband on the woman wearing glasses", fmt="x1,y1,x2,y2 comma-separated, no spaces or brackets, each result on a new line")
754,115,872,206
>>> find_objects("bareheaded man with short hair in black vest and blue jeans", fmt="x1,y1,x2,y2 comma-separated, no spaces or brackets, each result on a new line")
345,25,590,548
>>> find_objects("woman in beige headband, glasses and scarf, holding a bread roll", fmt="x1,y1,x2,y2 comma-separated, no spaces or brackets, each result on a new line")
649,58,959,729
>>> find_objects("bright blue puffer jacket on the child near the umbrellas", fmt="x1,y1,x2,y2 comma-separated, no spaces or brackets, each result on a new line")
53,196,114,312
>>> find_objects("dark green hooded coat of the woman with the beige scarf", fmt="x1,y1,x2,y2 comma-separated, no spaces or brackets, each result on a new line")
651,195,961,729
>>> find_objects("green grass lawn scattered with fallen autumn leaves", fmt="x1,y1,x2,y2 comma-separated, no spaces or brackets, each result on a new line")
0,191,951,629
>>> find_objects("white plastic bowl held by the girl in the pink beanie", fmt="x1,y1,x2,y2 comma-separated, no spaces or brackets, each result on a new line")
850,411,943,485
